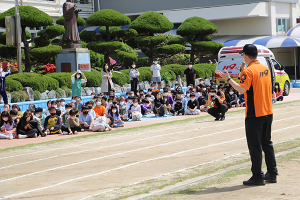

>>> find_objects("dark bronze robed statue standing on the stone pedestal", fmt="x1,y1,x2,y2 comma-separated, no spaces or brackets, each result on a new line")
62,0,82,48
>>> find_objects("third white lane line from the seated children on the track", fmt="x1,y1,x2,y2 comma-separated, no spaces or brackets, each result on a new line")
0,115,296,183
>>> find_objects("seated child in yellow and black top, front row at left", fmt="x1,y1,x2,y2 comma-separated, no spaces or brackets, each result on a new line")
44,107,62,135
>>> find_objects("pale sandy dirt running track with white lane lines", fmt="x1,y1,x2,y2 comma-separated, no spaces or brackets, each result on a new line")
0,101,300,199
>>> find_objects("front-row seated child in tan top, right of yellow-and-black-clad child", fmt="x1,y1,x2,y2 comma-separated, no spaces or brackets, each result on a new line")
62,109,81,135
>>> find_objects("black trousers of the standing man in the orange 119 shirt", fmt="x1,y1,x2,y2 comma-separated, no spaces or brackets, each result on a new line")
245,115,278,179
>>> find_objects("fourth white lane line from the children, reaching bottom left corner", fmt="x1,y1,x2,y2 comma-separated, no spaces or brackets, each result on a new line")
4,124,300,199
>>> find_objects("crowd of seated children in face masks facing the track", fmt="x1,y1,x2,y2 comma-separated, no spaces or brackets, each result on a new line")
0,79,251,139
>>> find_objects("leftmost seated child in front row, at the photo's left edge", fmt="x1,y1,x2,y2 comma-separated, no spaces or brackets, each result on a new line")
0,111,16,140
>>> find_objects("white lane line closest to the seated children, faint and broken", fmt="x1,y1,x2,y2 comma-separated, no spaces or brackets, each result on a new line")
0,109,298,160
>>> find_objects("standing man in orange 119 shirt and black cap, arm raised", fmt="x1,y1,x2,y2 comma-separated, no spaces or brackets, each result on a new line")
217,44,278,185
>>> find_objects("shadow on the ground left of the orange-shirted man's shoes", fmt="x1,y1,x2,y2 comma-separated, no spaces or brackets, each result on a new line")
171,185,249,195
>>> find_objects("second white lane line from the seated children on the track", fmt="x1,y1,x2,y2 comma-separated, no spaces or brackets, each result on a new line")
0,115,300,169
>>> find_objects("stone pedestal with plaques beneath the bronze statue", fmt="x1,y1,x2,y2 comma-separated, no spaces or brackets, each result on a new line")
56,48,91,72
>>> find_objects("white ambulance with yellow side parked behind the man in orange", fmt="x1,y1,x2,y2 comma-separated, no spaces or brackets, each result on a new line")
215,45,290,96
